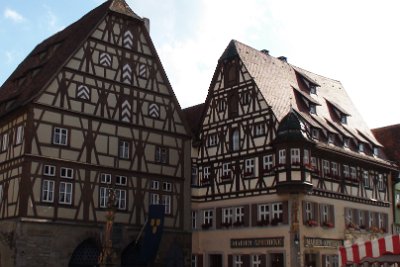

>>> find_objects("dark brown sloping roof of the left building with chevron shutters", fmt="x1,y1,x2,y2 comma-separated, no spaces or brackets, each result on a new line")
0,0,141,116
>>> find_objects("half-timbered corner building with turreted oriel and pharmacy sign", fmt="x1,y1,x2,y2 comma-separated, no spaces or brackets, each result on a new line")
185,40,395,267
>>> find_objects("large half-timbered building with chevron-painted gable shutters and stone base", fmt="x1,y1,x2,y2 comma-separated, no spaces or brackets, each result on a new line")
0,0,191,266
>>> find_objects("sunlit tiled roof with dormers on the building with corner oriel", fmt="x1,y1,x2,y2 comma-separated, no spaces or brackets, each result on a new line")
227,40,379,145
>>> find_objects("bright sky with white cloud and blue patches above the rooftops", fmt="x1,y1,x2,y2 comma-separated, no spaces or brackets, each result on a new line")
0,0,400,128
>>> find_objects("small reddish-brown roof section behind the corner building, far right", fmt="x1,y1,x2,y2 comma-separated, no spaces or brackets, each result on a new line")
372,124,400,165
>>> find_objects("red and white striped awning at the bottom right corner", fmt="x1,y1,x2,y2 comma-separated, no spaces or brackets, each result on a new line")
339,235,400,266
